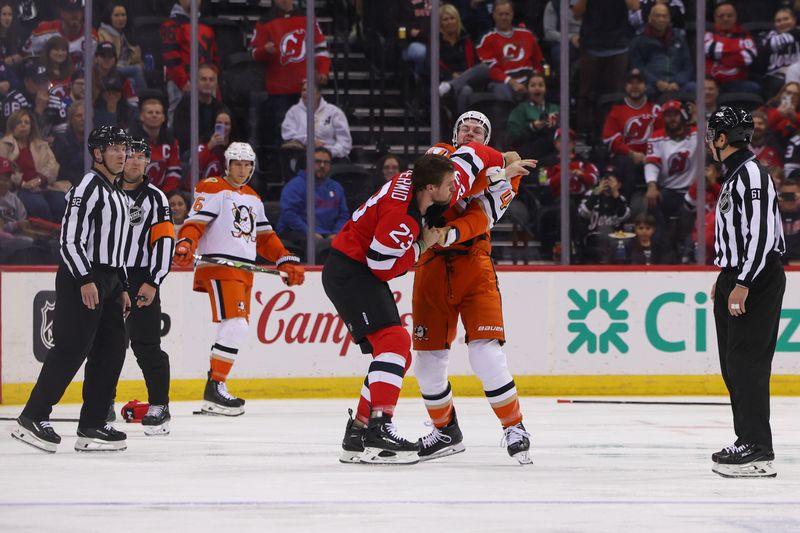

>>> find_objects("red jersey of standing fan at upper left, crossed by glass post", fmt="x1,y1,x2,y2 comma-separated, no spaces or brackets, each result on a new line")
161,9,219,88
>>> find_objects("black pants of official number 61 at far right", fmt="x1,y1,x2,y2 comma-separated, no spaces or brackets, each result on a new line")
714,258,786,450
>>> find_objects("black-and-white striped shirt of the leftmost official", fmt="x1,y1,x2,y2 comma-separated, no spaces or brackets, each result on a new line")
60,170,130,285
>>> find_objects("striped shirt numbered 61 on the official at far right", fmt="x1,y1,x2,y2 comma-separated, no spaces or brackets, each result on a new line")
714,149,786,287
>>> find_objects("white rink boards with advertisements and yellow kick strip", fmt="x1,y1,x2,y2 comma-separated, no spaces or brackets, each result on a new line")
0,268,800,403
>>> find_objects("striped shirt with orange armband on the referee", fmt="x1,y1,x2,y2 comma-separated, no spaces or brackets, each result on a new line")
125,177,175,287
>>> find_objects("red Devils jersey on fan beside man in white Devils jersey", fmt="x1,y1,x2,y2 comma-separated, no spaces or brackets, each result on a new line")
603,99,663,154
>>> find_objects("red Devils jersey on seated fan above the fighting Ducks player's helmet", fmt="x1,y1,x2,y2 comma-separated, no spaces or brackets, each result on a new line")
478,28,542,83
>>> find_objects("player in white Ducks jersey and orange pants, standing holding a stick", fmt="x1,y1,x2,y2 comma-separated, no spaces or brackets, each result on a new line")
174,142,305,416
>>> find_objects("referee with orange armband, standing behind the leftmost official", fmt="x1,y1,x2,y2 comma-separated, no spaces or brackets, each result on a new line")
122,139,175,435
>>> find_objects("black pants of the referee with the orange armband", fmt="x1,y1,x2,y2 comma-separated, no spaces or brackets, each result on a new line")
126,268,169,405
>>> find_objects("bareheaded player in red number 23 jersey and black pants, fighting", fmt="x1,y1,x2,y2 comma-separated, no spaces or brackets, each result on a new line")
322,155,457,464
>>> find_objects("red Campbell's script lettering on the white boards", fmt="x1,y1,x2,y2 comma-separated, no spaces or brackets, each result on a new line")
255,290,411,357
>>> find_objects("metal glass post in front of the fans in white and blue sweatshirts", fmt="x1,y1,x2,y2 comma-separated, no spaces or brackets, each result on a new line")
306,0,317,265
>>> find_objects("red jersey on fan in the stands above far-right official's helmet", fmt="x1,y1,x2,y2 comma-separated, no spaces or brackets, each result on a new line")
705,24,757,84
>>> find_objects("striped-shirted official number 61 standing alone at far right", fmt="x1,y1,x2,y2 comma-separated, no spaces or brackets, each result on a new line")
706,107,786,477
